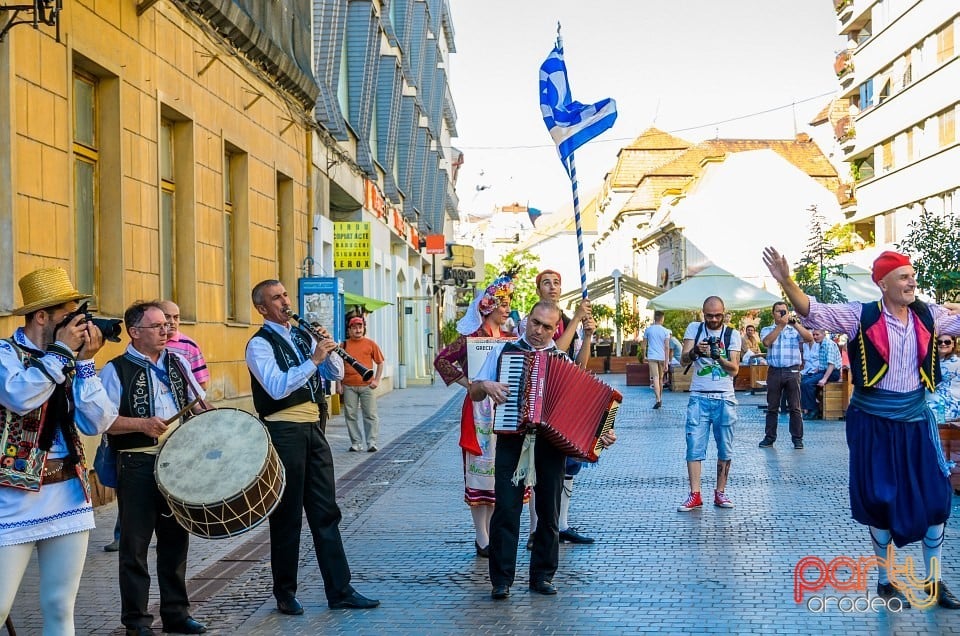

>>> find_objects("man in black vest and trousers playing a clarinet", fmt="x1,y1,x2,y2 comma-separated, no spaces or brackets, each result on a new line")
246,280,380,614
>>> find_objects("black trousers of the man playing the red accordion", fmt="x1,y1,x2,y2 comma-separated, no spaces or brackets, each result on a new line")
490,435,567,586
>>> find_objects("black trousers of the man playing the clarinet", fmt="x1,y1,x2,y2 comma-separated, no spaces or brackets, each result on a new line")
264,410,354,603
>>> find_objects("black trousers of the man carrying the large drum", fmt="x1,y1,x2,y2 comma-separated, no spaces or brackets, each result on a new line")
117,452,190,627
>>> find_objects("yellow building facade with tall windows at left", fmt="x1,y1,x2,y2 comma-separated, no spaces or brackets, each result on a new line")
0,0,316,432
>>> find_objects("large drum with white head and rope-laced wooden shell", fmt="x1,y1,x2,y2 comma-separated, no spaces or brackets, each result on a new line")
154,409,286,539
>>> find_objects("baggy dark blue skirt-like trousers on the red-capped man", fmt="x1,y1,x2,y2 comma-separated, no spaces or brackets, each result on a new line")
846,404,953,547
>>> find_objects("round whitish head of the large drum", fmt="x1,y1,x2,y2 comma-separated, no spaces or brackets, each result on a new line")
156,409,270,504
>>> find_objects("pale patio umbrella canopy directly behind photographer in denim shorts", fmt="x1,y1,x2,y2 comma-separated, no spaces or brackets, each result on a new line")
647,265,782,310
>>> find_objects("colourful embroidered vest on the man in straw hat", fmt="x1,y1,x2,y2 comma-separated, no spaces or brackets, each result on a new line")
0,338,90,494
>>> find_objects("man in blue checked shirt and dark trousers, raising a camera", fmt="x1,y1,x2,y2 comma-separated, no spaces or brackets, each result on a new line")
760,301,813,450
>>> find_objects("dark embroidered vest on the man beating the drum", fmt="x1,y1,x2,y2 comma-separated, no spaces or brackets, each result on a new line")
107,352,189,451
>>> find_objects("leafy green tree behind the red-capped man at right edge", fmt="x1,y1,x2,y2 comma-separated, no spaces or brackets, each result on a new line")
897,208,960,302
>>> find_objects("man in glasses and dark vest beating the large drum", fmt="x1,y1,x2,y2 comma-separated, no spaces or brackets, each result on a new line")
100,302,207,636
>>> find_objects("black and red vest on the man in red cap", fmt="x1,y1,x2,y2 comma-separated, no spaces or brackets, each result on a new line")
847,300,940,391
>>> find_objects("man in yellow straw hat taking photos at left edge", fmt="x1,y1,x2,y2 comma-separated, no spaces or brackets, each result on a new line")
0,267,117,634
